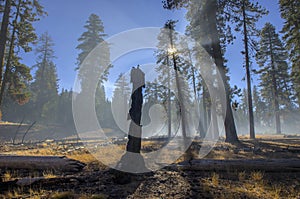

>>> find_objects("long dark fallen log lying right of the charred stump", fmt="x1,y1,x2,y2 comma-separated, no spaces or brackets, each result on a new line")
169,159,300,172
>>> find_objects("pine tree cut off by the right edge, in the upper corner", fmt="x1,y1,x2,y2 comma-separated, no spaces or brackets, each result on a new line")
279,0,300,104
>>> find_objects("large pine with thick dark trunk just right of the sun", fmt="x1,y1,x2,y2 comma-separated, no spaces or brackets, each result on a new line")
175,0,238,143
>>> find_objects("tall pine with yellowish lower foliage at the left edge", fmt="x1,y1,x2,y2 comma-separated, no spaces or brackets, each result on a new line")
0,0,45,117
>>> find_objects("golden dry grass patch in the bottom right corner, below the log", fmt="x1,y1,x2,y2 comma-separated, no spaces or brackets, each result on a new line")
201,172,300,199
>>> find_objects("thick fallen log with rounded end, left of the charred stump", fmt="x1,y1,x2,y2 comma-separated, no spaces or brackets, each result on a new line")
0,155,85,173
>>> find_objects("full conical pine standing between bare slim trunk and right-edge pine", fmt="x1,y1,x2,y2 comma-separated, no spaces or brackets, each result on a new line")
256,23,291,134
